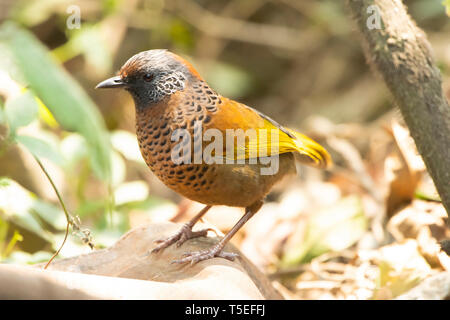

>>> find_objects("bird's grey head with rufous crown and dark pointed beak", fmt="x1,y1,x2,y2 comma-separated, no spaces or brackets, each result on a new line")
96,49,201,108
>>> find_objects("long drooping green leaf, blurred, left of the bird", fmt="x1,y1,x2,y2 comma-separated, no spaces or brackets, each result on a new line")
0,22,111,182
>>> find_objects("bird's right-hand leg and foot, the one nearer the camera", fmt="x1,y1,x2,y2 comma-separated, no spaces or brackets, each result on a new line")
172,201,263,264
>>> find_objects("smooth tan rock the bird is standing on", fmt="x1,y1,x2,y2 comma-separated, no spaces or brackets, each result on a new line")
16,223,282,299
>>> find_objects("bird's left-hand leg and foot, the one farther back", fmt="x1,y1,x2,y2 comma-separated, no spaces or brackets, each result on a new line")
152,206,212,253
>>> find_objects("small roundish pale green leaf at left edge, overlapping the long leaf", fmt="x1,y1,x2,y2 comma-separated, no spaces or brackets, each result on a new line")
5,91,39,133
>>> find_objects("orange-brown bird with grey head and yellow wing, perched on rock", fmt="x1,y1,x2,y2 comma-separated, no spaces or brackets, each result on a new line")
96,49,332,264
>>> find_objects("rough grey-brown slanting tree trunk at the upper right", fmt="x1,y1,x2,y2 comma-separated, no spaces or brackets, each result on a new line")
348,0,450,221
